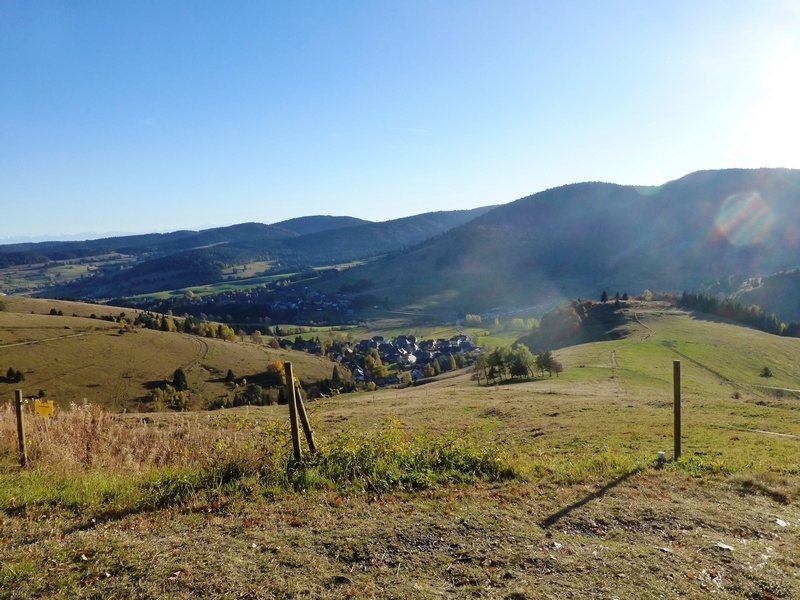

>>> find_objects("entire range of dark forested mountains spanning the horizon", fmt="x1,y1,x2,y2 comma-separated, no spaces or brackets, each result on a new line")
0,169,800,320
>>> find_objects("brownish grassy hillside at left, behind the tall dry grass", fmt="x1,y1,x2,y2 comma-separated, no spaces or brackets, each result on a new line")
0,300,332,410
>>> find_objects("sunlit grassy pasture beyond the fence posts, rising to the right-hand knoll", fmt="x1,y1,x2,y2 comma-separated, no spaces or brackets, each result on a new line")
270,304,800,477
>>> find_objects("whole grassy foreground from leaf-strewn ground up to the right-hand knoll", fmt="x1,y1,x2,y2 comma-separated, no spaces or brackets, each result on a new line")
0,305,800,600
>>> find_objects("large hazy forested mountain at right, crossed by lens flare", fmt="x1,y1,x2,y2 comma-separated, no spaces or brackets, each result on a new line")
330,169,800,313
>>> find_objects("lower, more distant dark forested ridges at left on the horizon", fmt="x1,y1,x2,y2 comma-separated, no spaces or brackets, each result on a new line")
0,207,490,299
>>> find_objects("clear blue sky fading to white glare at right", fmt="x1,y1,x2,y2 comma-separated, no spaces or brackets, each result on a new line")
0,0,800,243
